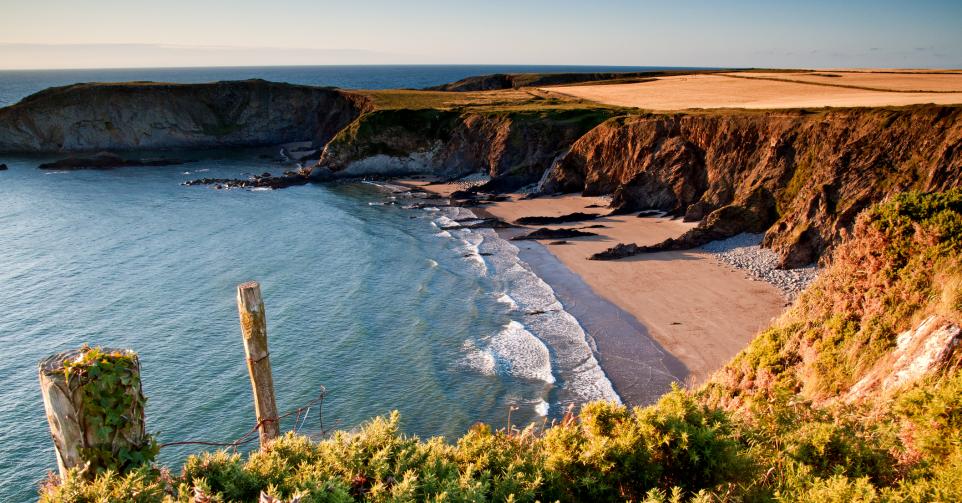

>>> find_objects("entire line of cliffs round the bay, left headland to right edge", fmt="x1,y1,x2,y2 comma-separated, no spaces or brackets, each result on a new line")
0,80,962,267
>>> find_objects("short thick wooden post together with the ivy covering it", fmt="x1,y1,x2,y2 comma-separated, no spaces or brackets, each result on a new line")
39,346,158,478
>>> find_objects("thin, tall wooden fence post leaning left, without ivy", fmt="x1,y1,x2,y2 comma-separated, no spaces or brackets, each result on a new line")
237,281,280,449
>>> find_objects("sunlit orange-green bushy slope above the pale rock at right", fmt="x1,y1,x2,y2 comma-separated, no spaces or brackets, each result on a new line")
718,189,962,399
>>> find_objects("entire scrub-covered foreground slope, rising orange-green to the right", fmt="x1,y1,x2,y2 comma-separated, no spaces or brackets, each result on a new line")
41,190,962,502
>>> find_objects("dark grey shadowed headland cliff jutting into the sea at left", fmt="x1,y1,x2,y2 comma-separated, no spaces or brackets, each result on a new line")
0,80,370,152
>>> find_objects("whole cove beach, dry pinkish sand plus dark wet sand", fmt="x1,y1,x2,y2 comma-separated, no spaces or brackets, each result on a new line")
397,179,788,396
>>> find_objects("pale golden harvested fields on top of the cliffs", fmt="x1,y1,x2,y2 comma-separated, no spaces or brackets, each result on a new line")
542,70,962,110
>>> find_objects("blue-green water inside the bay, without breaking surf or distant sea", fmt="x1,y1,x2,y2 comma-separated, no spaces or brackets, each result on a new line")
0,153,576,501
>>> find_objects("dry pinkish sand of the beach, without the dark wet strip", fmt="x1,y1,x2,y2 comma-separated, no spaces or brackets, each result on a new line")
405,181,786,384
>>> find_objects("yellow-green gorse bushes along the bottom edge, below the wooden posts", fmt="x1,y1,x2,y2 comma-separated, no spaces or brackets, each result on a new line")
42,389,747,502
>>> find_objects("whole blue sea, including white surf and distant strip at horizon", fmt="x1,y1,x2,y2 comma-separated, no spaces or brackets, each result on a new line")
0,66,680,502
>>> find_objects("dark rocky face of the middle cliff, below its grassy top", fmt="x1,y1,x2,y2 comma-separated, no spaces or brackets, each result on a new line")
312,108,615,190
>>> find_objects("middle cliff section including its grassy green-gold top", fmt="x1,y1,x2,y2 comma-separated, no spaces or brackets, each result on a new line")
313,90,625,190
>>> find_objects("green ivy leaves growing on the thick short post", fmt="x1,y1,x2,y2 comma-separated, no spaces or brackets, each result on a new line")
63,346,160,475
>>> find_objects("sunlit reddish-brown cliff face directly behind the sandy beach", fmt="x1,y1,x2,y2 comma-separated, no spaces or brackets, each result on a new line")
544,105,962,267
